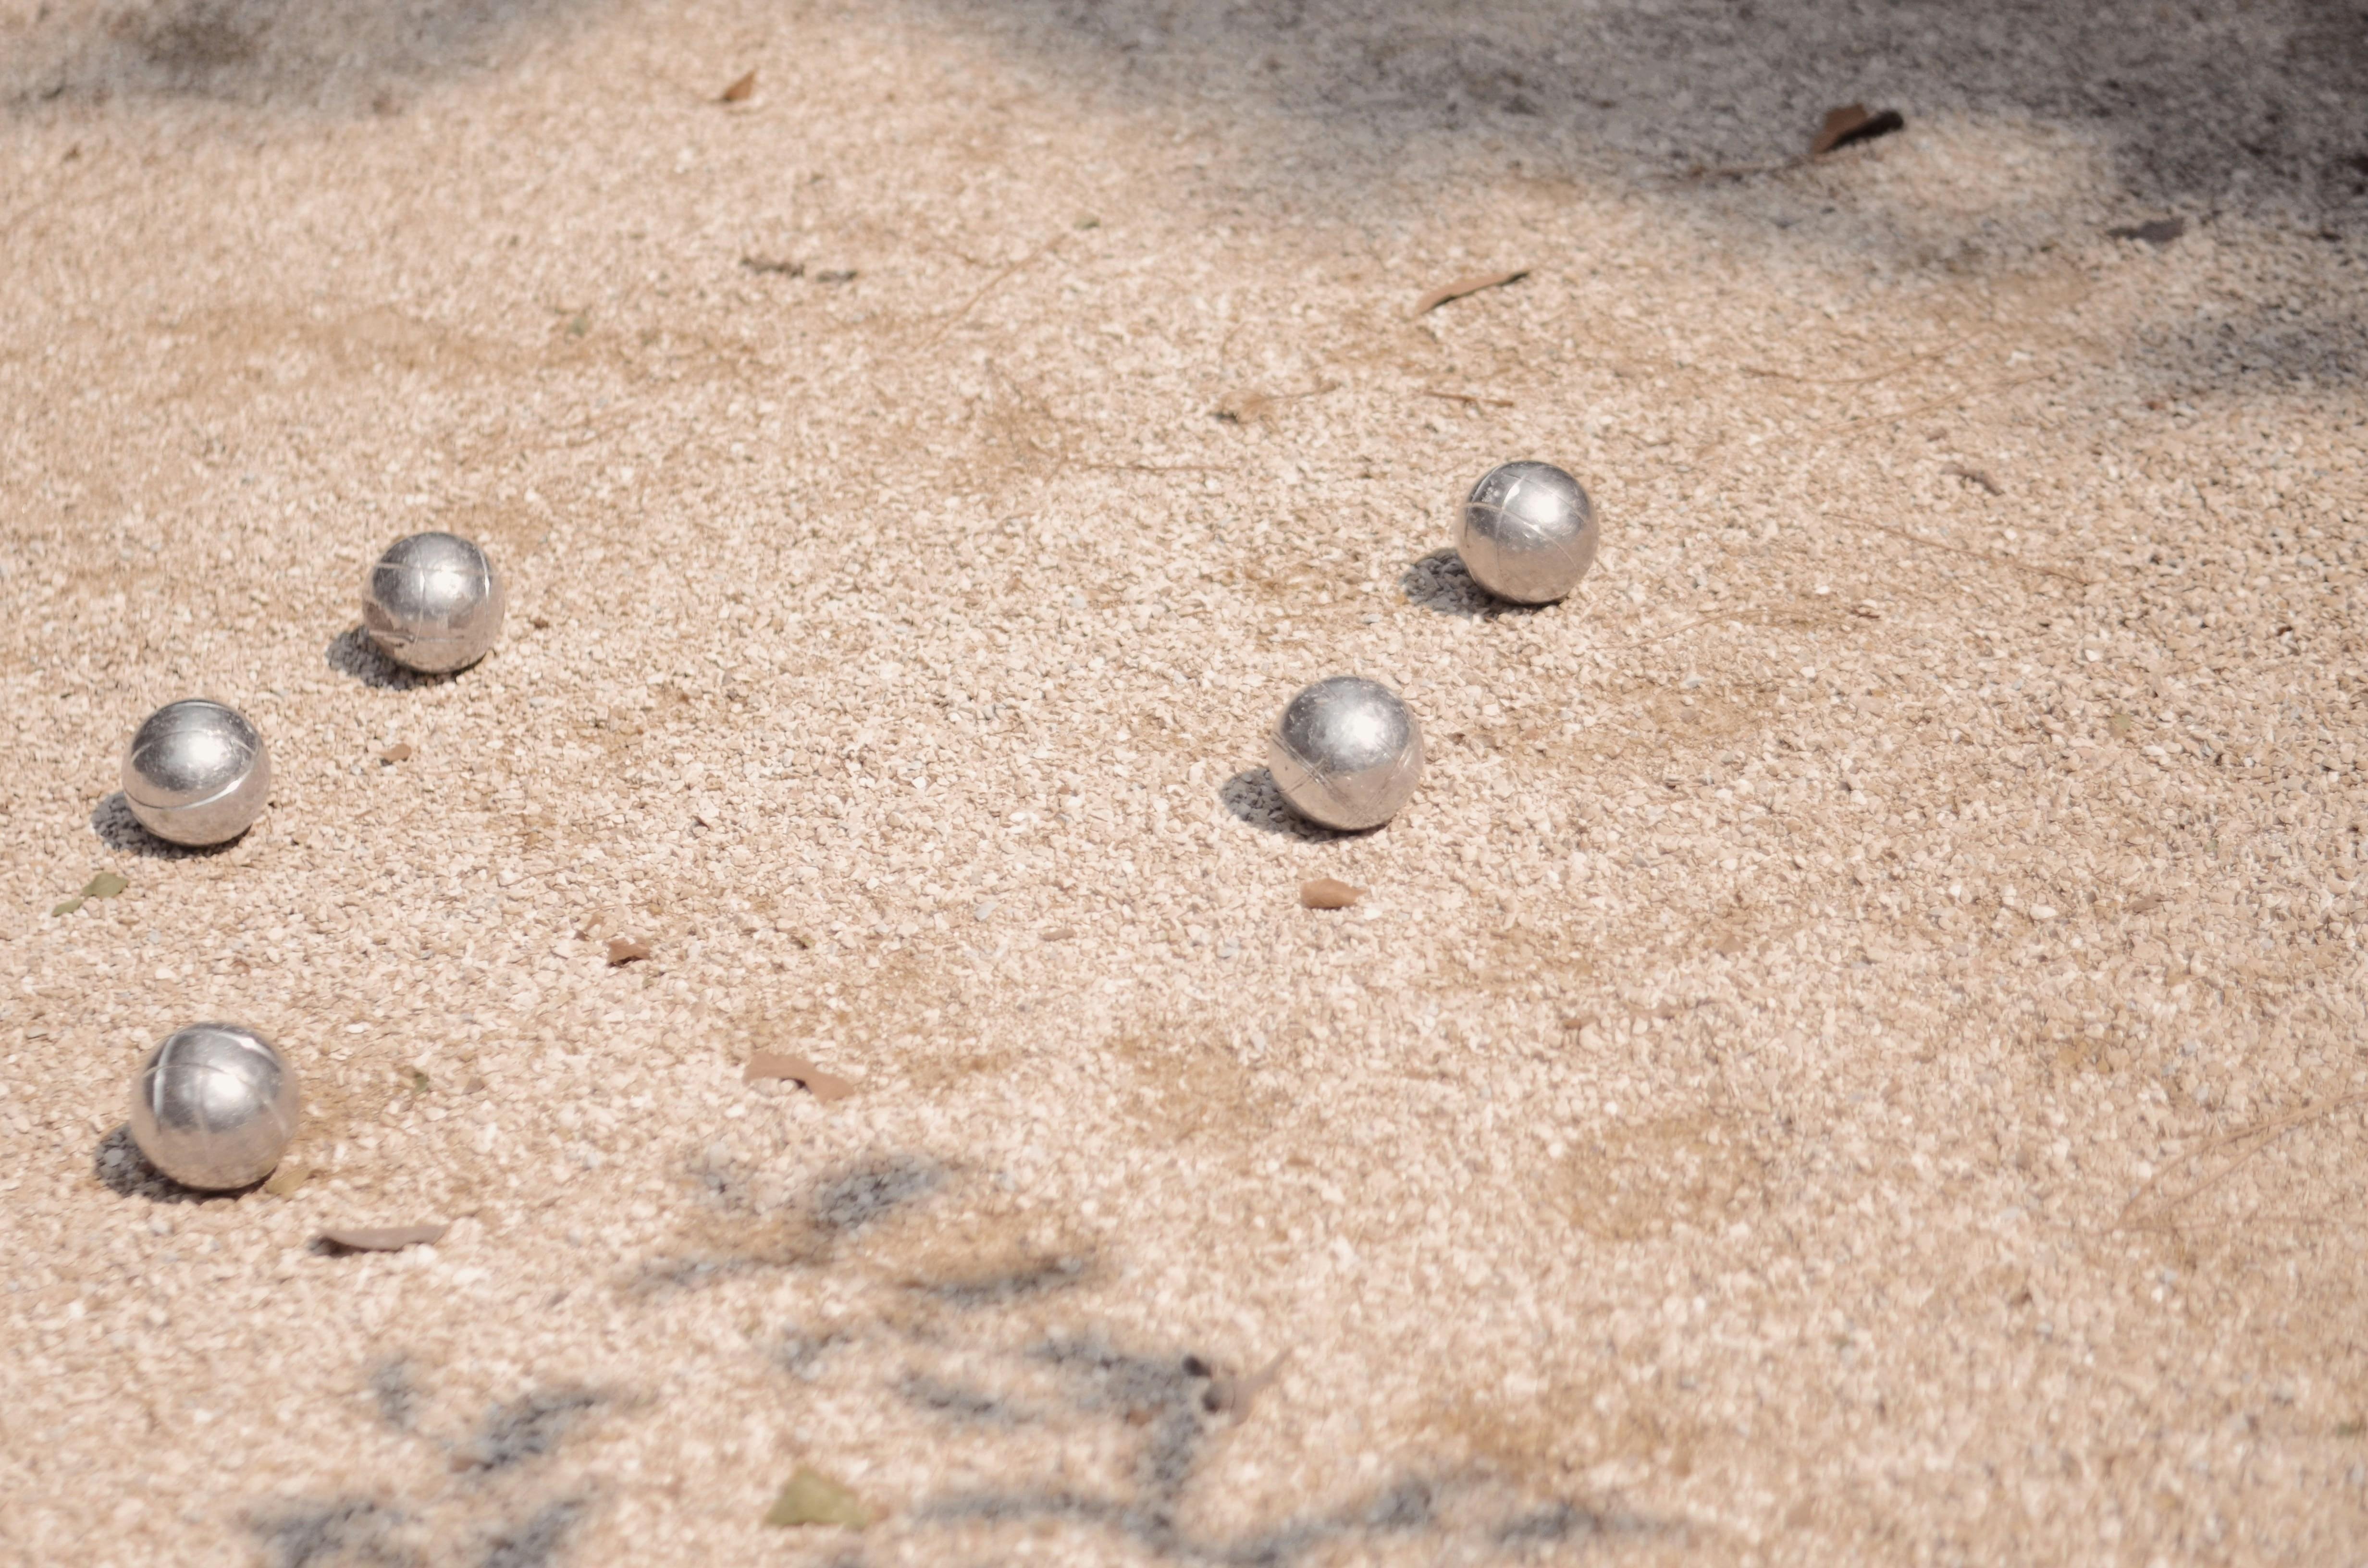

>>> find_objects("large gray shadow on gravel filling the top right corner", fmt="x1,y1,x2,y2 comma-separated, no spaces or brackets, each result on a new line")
904,0,2368,220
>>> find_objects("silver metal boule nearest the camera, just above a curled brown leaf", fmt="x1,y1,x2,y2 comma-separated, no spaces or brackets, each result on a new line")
133,1023,303,1191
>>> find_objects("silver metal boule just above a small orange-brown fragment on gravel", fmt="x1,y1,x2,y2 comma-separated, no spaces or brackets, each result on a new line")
1267,675,1423,832
